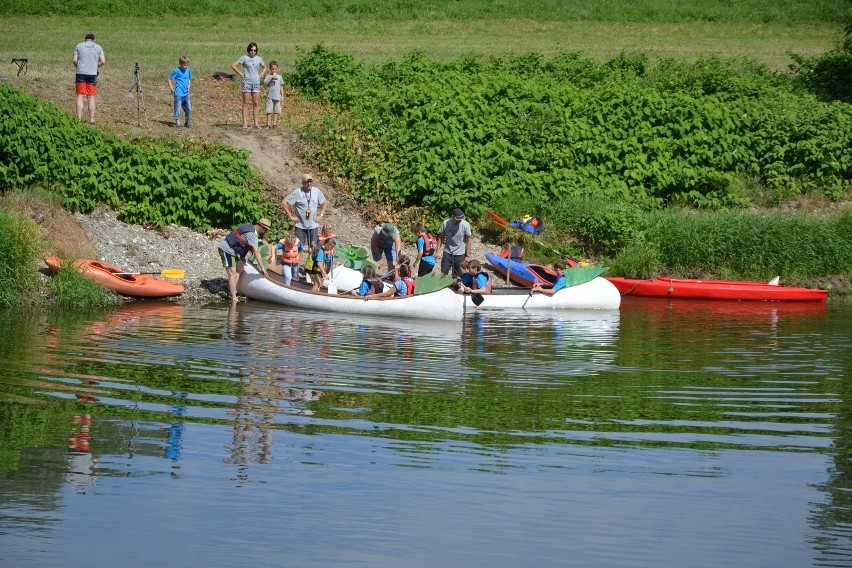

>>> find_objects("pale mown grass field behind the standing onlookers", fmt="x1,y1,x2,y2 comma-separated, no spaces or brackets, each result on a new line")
0,16,842,84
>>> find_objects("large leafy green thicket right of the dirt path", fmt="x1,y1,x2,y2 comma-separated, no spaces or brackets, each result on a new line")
292,47,852,221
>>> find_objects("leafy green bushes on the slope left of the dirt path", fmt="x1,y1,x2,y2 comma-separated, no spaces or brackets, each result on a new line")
0,85,270,230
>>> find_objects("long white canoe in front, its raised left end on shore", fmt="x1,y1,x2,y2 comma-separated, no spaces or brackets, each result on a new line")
237,264,472,321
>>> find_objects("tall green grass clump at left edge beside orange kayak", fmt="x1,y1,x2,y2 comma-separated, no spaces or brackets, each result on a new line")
0,209,41,308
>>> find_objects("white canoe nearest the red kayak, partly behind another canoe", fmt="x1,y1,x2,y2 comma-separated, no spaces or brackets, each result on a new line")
463,276,621,311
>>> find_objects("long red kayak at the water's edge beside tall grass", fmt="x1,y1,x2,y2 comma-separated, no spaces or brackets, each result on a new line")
606,277,828,302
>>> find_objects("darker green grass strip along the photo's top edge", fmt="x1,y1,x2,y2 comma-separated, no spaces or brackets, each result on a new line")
5,0,848,25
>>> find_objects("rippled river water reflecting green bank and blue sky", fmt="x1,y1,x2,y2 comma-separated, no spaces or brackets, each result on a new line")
0,298,852,568
